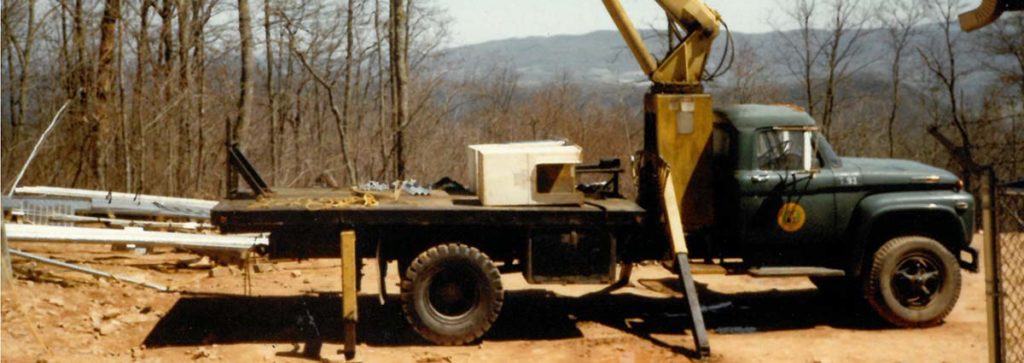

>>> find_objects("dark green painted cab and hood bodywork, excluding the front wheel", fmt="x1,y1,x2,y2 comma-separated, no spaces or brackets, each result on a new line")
716,105,975,268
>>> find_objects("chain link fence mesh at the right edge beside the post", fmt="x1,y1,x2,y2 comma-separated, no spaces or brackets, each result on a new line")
994,183,1024,362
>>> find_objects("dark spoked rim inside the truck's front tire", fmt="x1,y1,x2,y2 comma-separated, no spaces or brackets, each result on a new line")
892,253,945,309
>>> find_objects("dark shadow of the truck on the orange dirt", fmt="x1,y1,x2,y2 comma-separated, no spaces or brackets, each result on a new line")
143,279,887,355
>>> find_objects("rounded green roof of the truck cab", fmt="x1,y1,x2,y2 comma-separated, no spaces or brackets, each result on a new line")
715,105,815,131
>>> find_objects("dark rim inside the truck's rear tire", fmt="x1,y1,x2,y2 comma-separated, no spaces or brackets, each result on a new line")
427,266,479,319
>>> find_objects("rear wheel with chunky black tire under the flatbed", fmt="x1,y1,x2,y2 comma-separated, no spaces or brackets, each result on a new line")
400,243,505,346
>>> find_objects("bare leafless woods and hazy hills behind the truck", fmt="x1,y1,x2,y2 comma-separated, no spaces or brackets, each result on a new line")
0,0,1024,199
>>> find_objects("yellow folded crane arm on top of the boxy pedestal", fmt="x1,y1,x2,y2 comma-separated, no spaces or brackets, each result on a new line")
602,0,722,91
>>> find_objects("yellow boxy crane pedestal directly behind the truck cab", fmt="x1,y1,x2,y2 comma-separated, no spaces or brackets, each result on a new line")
644,93,715,229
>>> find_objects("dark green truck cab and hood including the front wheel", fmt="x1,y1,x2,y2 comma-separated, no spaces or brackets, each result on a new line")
700,105,978,327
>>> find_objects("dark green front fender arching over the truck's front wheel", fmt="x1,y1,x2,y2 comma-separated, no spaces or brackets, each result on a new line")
846,191,977,276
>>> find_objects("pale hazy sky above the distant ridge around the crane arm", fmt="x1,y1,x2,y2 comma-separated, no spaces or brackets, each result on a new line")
437,0,778,46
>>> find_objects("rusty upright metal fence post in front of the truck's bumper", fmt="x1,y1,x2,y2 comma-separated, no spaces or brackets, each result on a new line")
981,167,1002,363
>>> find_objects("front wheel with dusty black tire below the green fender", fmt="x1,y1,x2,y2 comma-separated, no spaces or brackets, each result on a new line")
863,236,961,328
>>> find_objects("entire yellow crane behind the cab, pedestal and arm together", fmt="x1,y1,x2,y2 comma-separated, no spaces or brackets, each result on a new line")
602,0,722,230
